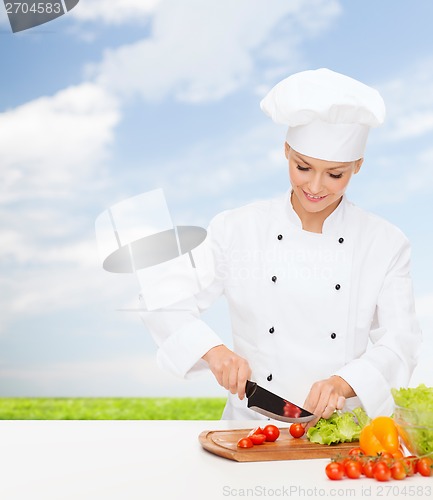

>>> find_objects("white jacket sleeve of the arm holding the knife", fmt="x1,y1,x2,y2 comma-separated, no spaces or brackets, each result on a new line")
140,213,228,378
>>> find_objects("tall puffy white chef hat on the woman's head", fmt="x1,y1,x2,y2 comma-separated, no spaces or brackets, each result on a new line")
260,68,385,162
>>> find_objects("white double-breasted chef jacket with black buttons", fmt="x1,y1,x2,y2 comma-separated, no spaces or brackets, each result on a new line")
141,192,421,420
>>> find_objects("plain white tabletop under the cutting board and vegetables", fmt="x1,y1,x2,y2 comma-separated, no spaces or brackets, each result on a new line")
0,421,433,500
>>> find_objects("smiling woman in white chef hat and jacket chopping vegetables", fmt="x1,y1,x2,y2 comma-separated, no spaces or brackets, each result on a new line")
143,69,421,420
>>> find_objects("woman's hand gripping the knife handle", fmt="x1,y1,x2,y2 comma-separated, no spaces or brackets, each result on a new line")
202,345,251,399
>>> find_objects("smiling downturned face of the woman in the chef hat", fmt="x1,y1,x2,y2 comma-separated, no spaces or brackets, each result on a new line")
285,143,363,213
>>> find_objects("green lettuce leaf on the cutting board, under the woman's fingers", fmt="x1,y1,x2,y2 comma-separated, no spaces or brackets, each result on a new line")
307,407,370,444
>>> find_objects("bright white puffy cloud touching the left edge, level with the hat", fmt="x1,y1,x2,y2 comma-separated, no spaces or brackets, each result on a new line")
0,83,119,204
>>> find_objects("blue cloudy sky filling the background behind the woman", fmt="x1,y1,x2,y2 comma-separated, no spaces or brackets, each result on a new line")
0,0,433,396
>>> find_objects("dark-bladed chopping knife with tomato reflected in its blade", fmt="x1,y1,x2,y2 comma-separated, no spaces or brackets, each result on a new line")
245,380,316,422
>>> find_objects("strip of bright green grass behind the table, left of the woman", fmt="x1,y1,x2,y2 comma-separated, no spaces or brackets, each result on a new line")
0,398,225,420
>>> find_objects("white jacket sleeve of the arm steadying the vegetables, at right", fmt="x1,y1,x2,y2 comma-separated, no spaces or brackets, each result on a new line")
336,237,421,417
